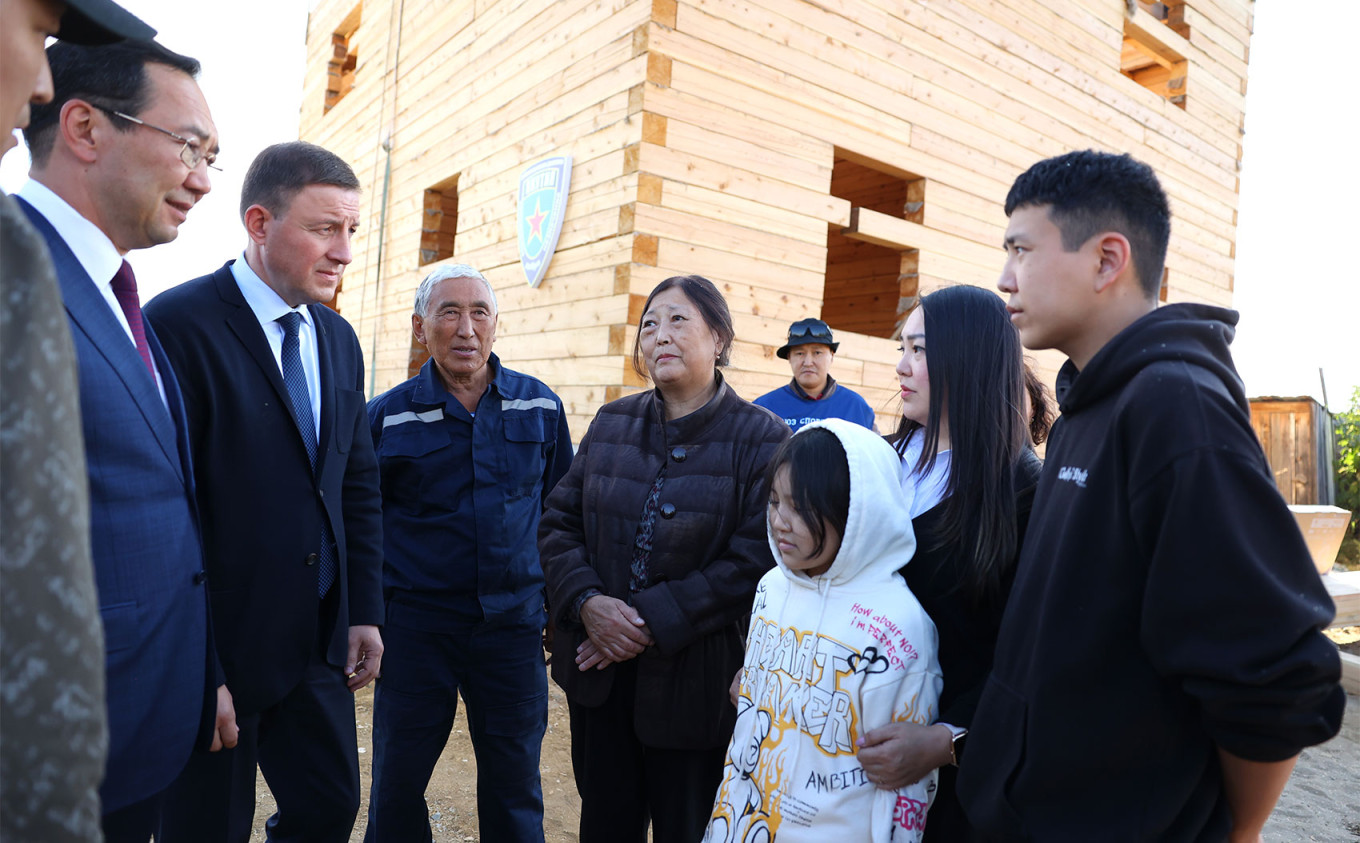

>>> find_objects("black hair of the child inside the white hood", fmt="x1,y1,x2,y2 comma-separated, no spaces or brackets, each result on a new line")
766,427,850,556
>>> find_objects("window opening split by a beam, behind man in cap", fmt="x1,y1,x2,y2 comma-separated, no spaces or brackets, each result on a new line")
821,156,926,339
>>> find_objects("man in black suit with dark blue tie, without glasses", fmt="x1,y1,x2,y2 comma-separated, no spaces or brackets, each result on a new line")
147,143,382,843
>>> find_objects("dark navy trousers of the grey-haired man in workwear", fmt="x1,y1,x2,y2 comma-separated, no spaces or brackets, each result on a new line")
364,604,548,843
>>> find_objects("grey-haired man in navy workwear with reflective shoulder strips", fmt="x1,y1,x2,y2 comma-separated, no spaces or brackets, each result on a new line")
364,265,571,843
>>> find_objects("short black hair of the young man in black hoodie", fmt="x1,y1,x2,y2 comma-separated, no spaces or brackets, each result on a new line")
1006,150,1171,300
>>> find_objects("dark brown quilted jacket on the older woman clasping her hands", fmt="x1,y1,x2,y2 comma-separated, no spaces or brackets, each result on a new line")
539,379,789,749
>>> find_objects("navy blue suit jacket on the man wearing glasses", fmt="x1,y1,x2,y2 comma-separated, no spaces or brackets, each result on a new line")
18,200,216,813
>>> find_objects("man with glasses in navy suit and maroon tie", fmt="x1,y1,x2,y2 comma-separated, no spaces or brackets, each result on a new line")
19,36,235,842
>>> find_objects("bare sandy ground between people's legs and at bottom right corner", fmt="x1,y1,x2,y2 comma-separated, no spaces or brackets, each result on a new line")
250,668,1360,843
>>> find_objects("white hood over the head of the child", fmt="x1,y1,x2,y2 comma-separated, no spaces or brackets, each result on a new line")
766,419,917,589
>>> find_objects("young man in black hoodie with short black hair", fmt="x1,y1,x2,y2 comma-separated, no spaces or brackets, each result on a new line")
959,151,1345,840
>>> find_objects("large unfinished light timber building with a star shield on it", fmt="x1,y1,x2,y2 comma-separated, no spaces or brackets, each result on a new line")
301,0,1254,436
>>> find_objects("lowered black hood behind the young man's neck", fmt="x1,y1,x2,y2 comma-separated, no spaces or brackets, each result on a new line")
1057,303,1248,413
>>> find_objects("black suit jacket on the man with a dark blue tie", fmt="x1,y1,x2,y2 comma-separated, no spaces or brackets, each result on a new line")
146,262,382,714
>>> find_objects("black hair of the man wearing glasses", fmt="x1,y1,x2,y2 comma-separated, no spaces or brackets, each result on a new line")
23,41,199,167
